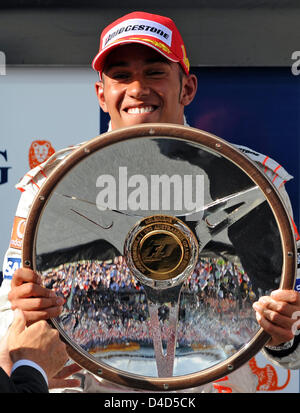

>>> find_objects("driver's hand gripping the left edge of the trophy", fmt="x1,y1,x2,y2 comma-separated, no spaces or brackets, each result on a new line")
8,268,64,325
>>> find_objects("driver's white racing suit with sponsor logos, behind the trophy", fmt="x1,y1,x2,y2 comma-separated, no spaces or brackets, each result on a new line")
0,138,300,393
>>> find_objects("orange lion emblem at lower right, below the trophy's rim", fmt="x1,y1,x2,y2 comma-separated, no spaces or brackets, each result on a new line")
249,357,291,391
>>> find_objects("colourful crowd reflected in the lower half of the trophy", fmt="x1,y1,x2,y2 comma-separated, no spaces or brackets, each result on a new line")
43,257,257,350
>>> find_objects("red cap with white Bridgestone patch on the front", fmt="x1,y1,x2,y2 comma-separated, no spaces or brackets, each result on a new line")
92,11,190,77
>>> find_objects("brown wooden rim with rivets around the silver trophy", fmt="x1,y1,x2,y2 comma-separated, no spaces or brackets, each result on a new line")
22,123,296,391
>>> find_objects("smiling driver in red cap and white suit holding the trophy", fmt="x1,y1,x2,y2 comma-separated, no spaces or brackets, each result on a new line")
0,12,300,392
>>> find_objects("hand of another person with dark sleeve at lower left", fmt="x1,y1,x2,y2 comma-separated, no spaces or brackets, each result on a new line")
7,310,68,379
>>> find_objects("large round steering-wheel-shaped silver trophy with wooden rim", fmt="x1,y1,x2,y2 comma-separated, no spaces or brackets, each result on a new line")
22,124,296,391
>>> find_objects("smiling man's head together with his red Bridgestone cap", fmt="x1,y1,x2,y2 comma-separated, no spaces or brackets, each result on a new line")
93,12,197,130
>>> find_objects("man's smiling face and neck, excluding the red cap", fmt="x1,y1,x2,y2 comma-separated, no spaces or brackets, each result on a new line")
96,44,196,130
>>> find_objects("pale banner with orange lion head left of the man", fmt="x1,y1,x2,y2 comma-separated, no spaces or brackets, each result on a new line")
0,67,99,270
